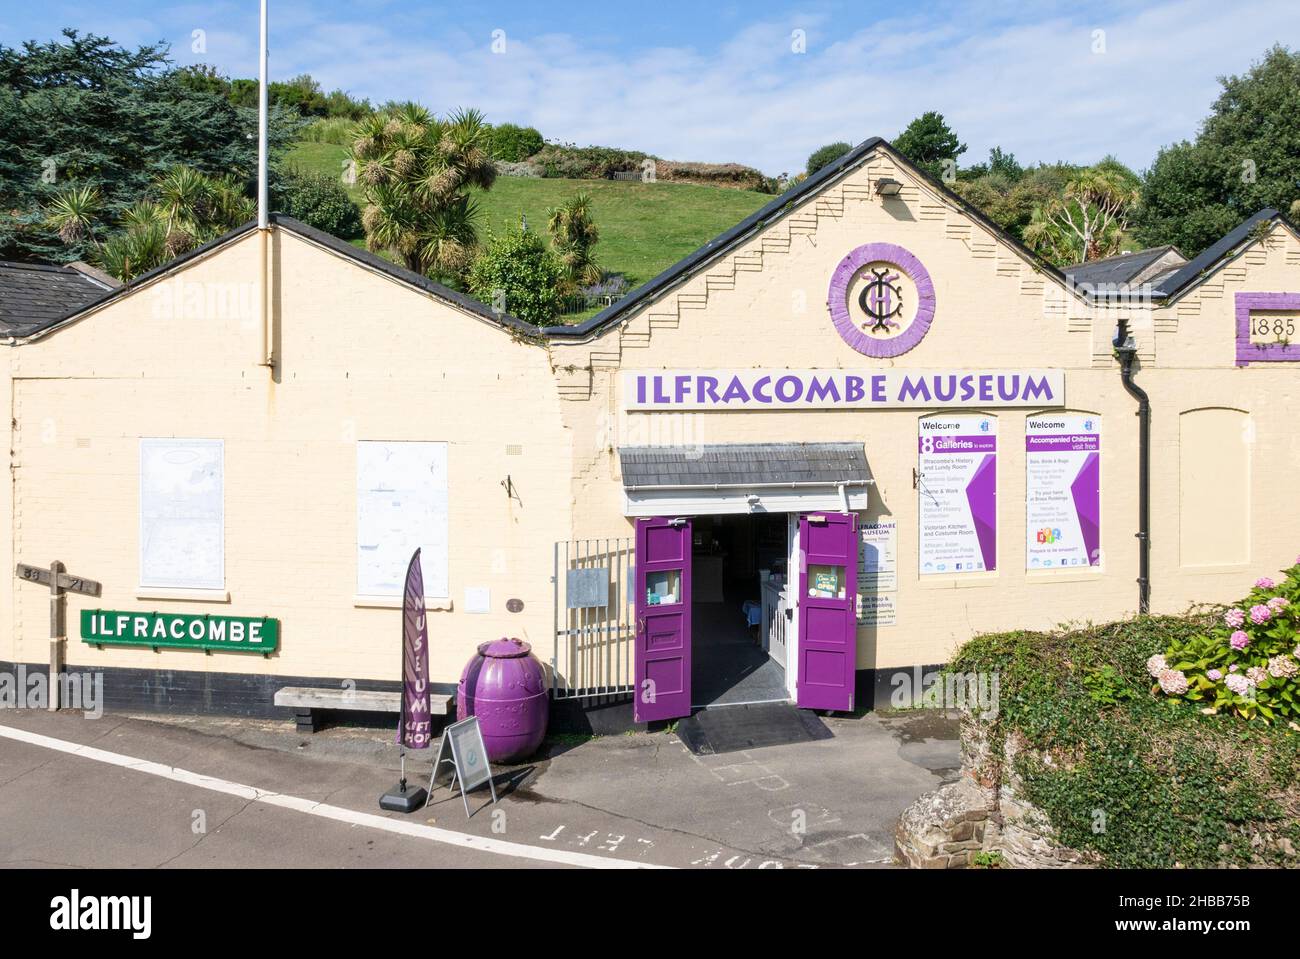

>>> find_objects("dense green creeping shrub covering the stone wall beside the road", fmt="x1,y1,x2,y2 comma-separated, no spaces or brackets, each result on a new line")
949,613,1300,868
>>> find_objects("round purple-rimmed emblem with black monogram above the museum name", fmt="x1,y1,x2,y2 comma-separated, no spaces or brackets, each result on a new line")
827,243,935,359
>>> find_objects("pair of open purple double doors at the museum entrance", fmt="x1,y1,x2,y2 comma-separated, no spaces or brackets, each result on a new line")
632,513,858,722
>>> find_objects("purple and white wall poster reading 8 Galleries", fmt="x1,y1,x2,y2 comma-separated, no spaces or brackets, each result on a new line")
917,415,997,576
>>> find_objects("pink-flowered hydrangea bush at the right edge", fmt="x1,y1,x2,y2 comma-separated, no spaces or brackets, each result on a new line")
1147,560,1300,722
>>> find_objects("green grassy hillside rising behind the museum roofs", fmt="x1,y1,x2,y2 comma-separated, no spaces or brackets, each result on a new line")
287,143,772,286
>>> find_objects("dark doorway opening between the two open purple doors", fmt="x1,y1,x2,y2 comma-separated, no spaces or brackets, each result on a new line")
690,513,790,708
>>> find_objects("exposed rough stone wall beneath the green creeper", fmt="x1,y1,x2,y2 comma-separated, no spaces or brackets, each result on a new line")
894,713,1093,869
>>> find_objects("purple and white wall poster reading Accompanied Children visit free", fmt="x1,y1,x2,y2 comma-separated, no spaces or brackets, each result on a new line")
1024,413,1101,569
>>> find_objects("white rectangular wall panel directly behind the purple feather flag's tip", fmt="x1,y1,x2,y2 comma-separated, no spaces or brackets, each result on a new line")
356,441,450,599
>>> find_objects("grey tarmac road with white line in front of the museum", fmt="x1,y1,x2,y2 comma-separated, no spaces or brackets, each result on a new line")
0,710,957,869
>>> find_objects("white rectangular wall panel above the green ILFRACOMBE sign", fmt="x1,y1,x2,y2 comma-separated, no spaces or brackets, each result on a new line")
140,439,226,590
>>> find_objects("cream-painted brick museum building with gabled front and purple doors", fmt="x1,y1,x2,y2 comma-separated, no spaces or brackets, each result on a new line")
0,140,1300,721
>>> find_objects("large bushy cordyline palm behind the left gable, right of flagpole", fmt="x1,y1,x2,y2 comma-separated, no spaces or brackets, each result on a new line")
352,103,497,281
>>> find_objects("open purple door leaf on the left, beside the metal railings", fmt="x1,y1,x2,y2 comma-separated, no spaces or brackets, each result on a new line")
632,516,690,722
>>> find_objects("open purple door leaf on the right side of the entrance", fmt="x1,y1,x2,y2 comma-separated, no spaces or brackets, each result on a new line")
796,513,858,711
